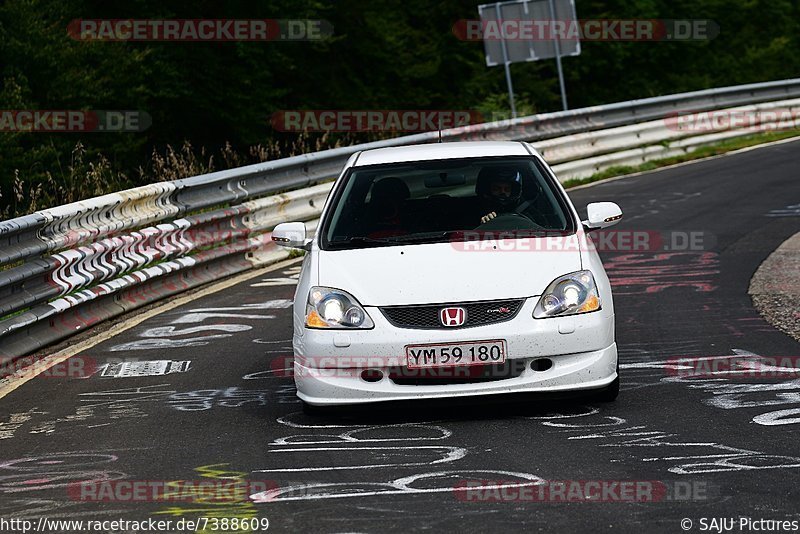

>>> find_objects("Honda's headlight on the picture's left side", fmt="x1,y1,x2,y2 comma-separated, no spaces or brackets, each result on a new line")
306,286,375,328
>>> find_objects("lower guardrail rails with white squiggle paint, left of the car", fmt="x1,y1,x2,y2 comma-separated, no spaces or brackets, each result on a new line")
0,183,332,358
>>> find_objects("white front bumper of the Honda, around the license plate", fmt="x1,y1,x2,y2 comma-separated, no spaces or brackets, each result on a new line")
294,298,617,406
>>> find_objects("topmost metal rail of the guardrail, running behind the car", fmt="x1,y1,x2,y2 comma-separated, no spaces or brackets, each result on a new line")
0,79,800,265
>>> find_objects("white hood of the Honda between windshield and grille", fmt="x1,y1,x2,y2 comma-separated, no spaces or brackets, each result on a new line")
318,235,581,306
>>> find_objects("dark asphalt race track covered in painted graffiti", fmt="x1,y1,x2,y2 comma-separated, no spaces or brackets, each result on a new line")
0,142,800,532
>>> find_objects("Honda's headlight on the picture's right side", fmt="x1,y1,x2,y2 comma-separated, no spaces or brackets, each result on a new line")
533,271,600,319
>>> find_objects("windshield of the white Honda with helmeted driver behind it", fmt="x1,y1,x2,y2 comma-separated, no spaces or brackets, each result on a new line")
321,157,574,249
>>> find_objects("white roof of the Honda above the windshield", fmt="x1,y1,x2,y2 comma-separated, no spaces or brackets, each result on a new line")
355,141,530,167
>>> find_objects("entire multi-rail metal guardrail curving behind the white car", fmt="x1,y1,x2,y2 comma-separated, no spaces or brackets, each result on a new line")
0,79,800,358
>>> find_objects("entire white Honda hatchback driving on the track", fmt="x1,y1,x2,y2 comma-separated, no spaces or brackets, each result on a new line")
272,142,622,409
